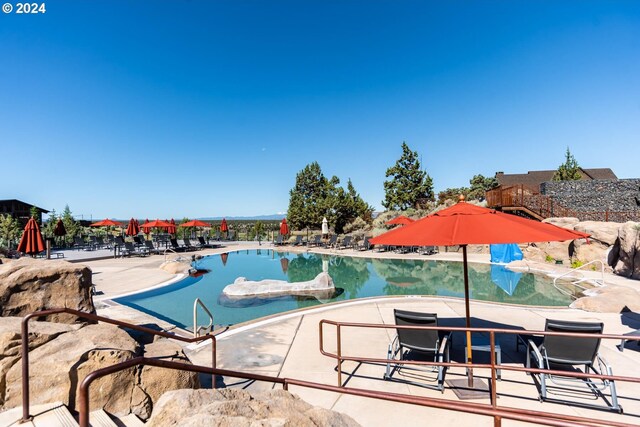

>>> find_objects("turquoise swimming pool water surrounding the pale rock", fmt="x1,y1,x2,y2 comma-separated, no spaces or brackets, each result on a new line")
116,249,572,329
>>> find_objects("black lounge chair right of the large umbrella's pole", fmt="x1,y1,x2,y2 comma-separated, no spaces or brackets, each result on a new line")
527,319,622,413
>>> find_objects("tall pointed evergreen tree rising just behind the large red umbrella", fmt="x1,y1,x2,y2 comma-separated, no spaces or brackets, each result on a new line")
382,142,434,210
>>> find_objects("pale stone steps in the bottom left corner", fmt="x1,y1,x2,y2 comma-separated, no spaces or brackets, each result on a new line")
0,402,144,427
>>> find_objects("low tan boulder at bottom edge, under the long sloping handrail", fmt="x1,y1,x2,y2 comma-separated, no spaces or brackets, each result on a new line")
147,389,359,427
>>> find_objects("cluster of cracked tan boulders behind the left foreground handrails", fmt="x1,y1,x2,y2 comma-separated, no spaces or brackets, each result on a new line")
0,318,199,419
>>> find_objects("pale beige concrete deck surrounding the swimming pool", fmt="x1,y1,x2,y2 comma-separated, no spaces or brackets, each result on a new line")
46,243,640,426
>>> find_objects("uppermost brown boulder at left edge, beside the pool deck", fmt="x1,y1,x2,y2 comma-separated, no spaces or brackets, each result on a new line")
0,257,95,323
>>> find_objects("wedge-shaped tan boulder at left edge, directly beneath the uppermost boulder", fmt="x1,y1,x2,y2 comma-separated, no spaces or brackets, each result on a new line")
0,317,81,407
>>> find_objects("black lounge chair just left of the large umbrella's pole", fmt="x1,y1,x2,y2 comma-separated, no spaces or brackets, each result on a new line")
384,310,451,393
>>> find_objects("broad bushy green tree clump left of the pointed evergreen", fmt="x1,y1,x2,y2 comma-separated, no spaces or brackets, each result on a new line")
287,162,373,233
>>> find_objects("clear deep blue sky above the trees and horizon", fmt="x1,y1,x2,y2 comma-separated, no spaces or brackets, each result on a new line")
0,0,640,219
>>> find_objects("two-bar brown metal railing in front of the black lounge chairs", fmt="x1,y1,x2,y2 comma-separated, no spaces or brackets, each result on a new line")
319,319,640,425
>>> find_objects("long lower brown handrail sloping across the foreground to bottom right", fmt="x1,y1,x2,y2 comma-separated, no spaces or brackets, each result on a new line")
78,357,633,427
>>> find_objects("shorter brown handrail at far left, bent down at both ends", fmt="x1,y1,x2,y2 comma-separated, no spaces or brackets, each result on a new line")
20,308,216,423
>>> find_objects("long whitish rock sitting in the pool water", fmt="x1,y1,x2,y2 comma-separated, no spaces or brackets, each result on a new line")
222,272,335,298
